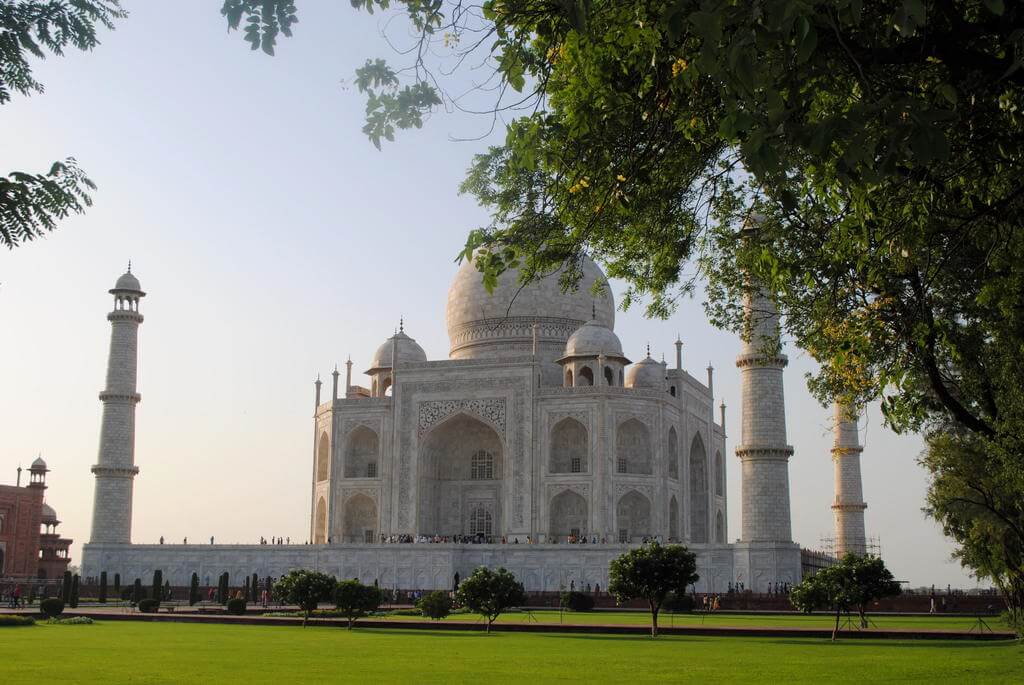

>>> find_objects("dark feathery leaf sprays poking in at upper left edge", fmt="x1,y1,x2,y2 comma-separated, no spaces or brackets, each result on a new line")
0,0,126,248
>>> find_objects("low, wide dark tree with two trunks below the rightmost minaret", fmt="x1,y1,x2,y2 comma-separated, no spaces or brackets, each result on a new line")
790,554,900,642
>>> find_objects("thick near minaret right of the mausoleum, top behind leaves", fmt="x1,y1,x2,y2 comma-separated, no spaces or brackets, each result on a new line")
736,282,793,543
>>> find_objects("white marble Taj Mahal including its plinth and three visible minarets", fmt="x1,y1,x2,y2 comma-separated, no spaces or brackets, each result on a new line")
82,253,866,592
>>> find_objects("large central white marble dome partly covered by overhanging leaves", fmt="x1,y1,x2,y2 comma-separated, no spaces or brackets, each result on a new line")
446,257,615,361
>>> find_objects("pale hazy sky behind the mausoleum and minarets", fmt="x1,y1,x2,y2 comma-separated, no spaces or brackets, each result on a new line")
0,0,975,587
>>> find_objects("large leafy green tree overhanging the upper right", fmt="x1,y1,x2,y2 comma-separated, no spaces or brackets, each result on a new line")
224,0,1024,610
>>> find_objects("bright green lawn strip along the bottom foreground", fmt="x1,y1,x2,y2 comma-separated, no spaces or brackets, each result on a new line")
0,622,1024,685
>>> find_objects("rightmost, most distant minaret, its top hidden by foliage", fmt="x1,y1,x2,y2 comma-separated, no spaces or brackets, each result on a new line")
833,402,867,557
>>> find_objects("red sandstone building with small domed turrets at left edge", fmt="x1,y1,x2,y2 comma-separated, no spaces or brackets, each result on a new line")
0,458,72,581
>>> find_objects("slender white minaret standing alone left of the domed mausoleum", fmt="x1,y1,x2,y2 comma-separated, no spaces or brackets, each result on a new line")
89,262,145,545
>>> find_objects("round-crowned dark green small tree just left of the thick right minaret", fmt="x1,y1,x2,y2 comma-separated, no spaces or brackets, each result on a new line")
608,543,700,637
